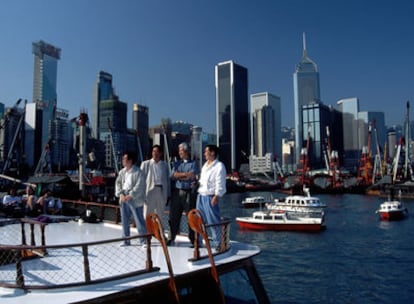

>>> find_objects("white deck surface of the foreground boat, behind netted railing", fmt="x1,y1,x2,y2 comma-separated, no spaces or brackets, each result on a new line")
0,217,260,304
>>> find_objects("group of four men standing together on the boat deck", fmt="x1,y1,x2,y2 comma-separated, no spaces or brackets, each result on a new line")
115,143,226,246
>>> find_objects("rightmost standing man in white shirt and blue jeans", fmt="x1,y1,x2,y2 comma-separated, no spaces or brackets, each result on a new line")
196,145,227,250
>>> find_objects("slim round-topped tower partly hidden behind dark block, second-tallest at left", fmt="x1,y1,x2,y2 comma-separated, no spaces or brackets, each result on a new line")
92,71,114,139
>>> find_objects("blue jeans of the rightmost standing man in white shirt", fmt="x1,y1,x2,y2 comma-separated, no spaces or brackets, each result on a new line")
196,194,221,247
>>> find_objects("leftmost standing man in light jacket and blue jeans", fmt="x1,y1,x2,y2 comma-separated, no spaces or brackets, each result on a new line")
115,152,147,247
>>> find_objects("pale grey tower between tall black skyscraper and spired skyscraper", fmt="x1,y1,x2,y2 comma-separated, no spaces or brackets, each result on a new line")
250,92,282,158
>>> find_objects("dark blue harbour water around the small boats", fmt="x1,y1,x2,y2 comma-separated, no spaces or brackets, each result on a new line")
220,193,414,303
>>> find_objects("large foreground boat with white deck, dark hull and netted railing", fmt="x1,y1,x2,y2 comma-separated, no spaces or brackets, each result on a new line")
0,205,270,304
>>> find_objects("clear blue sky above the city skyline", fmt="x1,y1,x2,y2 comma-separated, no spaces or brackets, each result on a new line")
0,0,414,132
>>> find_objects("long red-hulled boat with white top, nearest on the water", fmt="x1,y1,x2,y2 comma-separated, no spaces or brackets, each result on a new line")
236,211,324,231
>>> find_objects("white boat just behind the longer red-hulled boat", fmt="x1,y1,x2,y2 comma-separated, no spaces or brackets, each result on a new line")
266,188,326,213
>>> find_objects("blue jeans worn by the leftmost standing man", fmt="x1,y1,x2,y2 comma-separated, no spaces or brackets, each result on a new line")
120,201,147,244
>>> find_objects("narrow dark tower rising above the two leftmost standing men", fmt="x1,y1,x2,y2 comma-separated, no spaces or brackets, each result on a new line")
132,103,150,161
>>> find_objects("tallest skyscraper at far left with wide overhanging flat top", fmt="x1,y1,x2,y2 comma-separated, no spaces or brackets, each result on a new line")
26,40,61,169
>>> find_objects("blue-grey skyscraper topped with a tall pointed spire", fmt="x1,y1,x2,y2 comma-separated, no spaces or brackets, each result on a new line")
293,34,320,163
